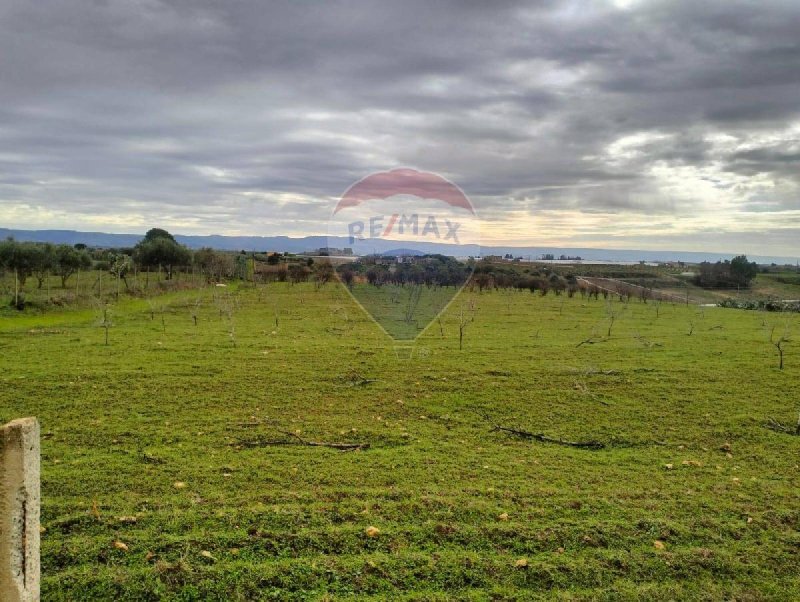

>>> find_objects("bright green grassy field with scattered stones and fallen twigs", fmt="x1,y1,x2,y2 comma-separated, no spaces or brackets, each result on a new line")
0,284,800,601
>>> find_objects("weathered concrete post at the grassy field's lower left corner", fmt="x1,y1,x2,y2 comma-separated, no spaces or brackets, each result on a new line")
0,418,40,602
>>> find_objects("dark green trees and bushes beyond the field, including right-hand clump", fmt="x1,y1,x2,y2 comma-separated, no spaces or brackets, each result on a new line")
7,228,758,302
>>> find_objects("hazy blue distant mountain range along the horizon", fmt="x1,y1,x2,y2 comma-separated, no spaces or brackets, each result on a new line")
0,228,798,265
